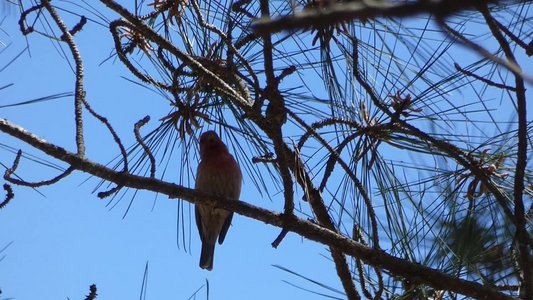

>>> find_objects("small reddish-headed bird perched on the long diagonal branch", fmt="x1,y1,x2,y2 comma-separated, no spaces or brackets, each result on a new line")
195,131,242,270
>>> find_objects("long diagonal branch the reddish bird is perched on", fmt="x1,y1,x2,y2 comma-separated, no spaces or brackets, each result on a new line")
0,119,512,299
